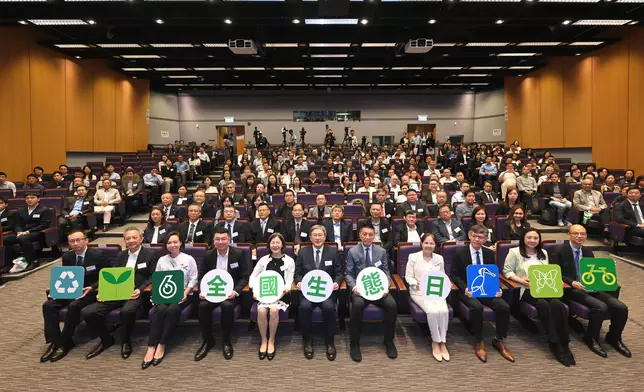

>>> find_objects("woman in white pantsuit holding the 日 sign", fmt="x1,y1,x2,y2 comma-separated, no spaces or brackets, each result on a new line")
405,233,449,362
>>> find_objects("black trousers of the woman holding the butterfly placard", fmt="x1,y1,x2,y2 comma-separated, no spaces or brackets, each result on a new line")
521,290,570,346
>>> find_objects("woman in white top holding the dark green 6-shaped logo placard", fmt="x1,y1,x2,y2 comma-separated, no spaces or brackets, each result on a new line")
141,231,199,370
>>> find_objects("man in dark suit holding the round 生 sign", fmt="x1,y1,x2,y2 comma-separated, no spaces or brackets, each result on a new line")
294,225,344,361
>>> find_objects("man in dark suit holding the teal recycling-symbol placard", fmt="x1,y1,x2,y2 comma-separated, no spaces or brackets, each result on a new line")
40,231,109,362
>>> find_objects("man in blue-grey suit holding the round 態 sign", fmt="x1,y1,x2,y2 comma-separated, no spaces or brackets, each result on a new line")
345,223,398,362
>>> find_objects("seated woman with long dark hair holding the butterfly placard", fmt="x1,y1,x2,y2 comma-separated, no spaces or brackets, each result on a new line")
503,229,576,366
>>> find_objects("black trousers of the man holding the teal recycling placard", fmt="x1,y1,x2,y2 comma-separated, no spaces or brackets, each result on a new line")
42,291,96,348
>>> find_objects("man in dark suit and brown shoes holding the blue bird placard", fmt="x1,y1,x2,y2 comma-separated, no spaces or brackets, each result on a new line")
450,225,514,362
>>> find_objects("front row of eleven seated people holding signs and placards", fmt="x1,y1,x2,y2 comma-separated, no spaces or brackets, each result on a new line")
41,222,631,369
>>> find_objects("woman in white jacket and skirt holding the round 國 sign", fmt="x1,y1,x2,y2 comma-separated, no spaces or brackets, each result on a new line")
250,233,295,361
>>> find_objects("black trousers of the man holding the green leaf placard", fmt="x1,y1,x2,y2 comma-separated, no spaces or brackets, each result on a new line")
81,293,149,343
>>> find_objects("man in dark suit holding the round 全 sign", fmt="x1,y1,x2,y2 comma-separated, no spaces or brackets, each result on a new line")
195,226,250,361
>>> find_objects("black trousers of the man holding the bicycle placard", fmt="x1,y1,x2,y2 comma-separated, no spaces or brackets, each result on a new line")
567,289,628,340
